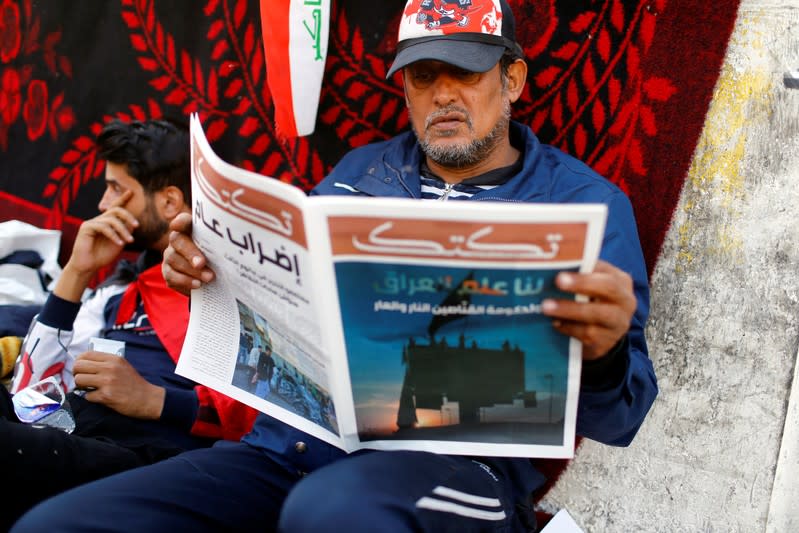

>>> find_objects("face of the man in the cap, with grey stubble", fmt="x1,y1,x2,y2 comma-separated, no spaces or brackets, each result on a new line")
403,61,510,168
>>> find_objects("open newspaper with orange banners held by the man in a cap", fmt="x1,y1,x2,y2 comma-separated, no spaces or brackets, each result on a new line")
177,117,606,458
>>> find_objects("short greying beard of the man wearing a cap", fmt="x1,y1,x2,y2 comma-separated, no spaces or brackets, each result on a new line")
413,100,511,168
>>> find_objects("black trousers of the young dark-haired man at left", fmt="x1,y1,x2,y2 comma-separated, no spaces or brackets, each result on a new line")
0,386,182,531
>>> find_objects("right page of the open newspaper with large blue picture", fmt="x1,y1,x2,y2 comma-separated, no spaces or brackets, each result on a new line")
312,206,605,457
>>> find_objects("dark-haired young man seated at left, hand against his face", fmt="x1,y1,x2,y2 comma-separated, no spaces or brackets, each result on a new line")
0,117,254,530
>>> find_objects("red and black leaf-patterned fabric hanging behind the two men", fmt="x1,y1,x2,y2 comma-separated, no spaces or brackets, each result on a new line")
0,0,738,508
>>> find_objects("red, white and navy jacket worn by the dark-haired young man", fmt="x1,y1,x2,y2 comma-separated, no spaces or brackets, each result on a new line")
11,252,257,440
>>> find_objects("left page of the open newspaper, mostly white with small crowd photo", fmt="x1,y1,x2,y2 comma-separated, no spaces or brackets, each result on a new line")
177,114,339,442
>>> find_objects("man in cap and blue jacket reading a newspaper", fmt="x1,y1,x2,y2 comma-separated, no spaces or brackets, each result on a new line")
15,0,657,532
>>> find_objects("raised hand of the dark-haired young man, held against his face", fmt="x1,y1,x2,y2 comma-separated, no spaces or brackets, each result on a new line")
53,191,139,302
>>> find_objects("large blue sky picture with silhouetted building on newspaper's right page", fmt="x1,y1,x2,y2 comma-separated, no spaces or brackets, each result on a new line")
336,262,580,443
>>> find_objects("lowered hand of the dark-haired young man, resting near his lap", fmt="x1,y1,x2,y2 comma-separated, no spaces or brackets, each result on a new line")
73,352,166,420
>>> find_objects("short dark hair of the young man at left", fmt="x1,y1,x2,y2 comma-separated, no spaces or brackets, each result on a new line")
97,119,191,203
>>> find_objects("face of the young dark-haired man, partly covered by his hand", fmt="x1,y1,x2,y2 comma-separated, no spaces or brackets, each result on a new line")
98,162,169,250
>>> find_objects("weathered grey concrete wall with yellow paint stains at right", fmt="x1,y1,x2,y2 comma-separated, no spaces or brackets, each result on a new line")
542,0,799,533
